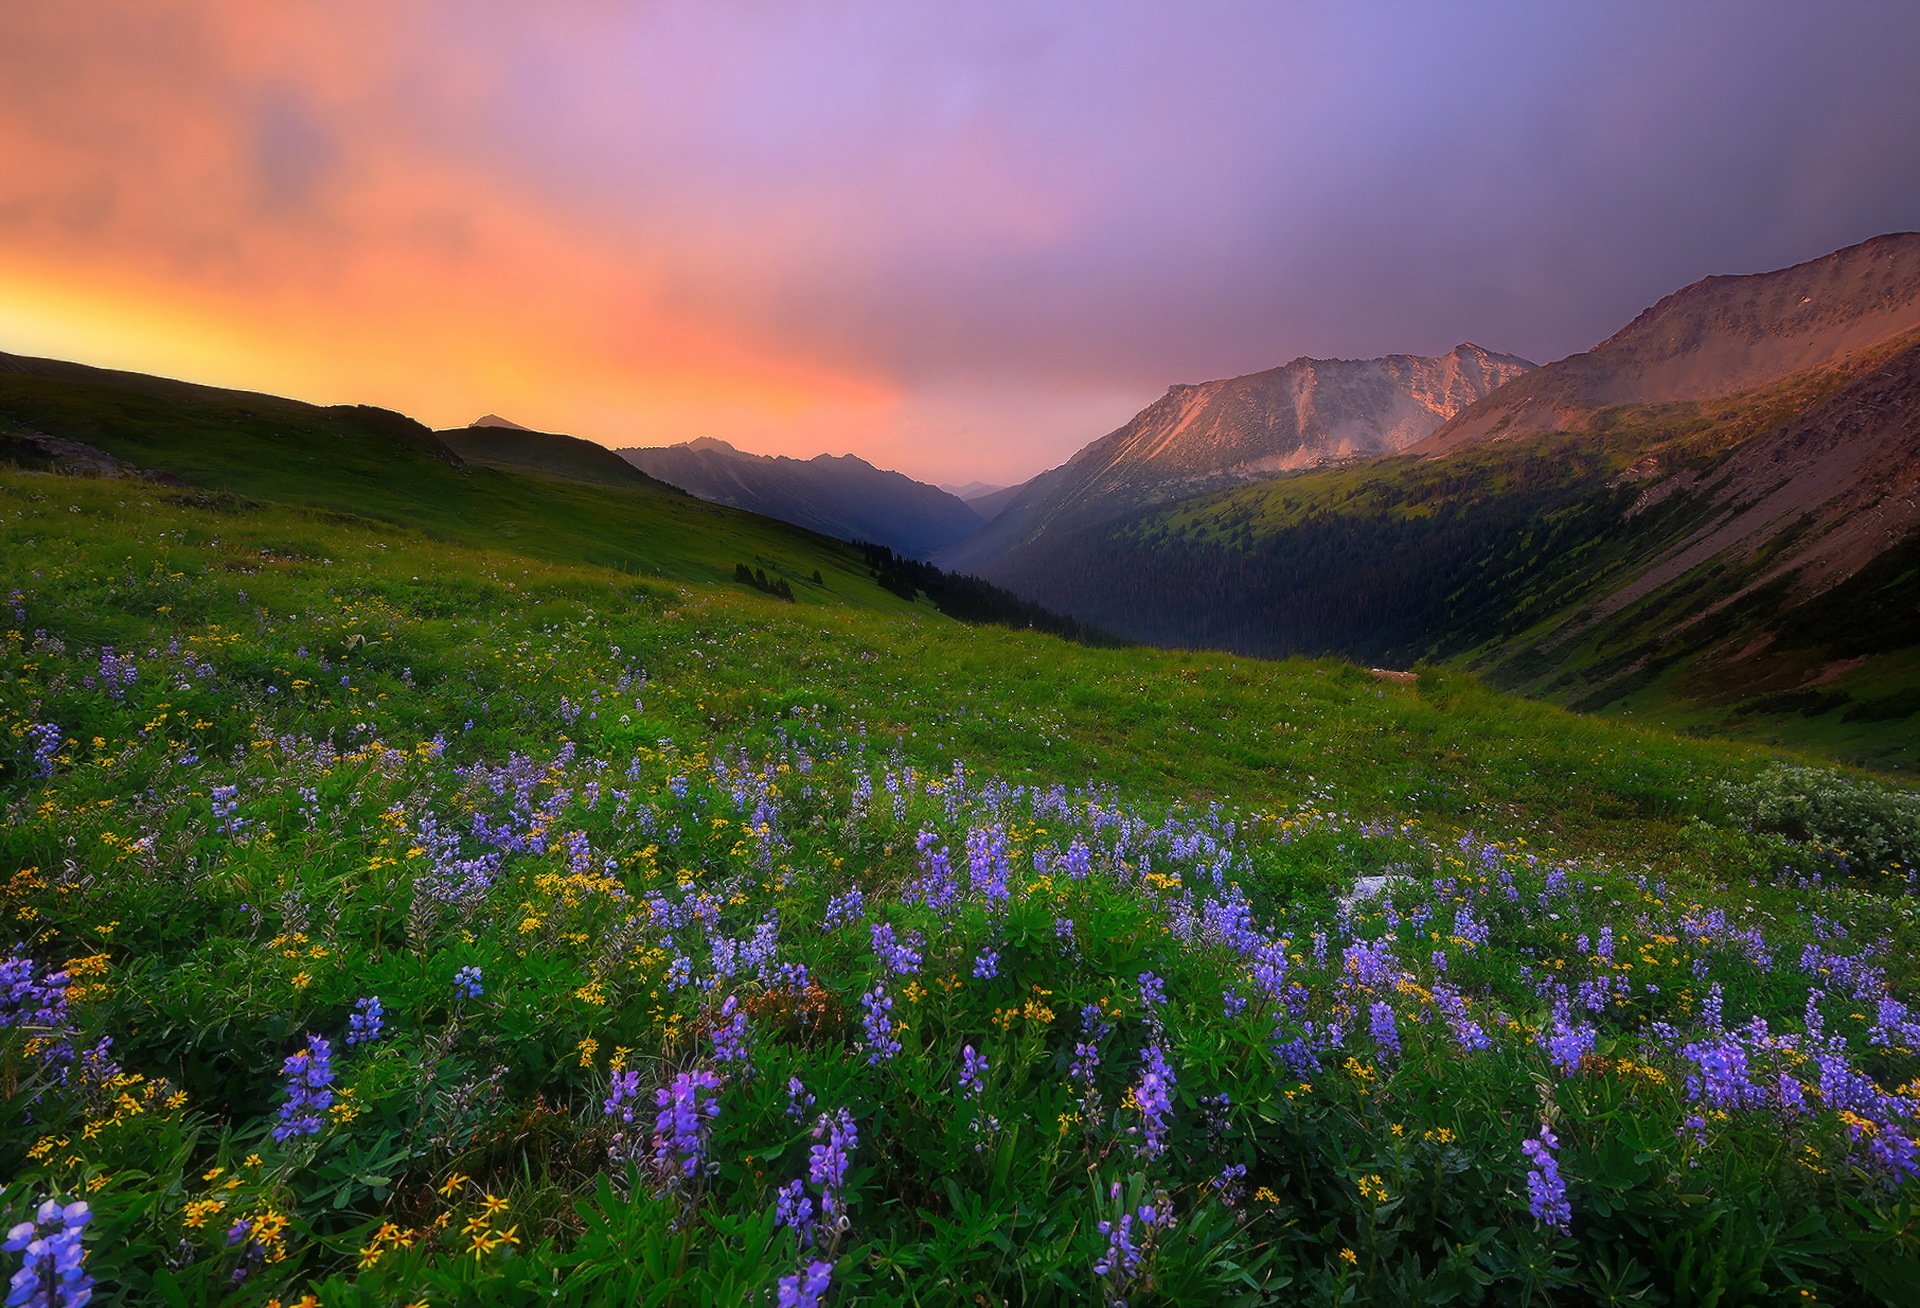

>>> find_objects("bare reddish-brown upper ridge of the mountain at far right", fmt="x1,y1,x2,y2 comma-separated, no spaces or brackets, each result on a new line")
1415,232,1920,457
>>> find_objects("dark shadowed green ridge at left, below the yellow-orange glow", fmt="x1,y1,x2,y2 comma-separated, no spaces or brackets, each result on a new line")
0,353,931,617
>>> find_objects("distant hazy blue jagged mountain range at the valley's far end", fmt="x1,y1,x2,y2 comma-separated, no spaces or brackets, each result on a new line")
618,436,981,559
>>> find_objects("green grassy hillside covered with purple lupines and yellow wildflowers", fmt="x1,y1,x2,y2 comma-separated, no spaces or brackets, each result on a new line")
0,359,1920,1308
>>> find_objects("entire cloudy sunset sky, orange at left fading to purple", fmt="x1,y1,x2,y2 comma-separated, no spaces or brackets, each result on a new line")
0,0,1920,482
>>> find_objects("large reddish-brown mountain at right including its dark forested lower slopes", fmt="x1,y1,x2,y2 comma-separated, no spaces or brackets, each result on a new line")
967,236,1920,766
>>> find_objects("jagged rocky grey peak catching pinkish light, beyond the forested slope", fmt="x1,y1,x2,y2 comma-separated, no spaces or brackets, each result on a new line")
941,344,1534,576
